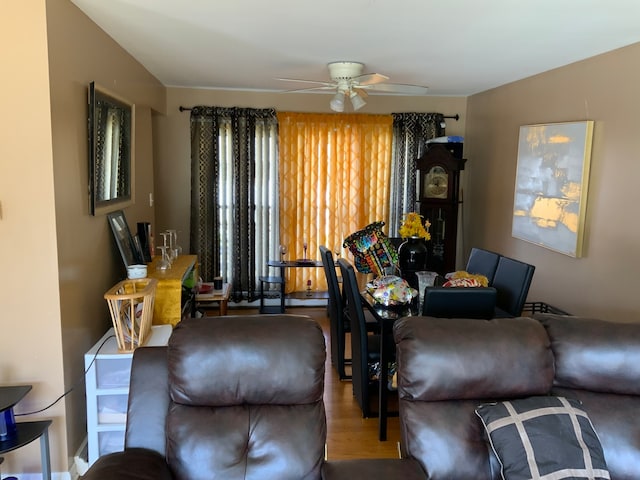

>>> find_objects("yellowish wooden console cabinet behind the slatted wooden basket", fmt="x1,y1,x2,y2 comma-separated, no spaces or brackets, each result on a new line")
147,255,198,327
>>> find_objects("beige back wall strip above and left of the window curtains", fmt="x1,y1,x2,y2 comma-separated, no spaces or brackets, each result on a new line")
154,88,466,244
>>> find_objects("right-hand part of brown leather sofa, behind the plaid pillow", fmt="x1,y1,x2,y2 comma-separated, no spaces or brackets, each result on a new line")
394,314,640,480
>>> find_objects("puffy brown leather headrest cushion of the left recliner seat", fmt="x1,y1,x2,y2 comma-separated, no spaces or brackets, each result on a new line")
167,315,325,406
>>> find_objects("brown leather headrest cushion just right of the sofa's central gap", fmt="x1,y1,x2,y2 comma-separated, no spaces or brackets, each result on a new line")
393,316,553,401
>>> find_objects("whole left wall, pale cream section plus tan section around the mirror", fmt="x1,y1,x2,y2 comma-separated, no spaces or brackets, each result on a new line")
0,0,166,473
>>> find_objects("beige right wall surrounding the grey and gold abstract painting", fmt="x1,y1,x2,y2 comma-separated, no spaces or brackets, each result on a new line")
465,44,640,321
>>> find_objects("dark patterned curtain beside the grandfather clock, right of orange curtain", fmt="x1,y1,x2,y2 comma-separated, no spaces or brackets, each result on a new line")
389,113,445,237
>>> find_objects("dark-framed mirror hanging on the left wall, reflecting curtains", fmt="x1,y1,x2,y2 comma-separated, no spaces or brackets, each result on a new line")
89,82,135,215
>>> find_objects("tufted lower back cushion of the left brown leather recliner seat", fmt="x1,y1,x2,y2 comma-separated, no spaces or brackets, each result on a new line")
167,404,327,480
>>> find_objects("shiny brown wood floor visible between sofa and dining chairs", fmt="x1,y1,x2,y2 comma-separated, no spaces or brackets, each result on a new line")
222,307,400,460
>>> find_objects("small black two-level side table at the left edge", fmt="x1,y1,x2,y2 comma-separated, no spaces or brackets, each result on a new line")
0,385,51,480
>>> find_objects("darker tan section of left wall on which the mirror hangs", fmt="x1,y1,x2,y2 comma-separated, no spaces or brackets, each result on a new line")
47,0,166,470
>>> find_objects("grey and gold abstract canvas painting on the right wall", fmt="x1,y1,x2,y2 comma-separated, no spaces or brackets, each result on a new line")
512,120,593,257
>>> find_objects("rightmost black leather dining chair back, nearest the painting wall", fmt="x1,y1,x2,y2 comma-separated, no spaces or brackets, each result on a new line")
491,256,536,318
